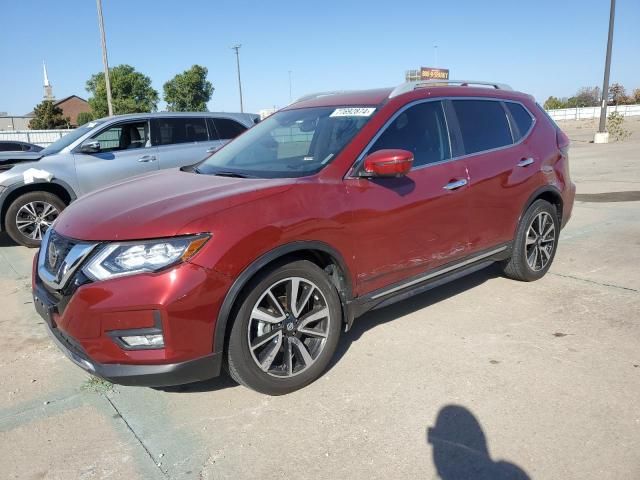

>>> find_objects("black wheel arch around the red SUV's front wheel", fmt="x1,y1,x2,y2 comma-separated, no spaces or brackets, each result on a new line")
213,241,353,352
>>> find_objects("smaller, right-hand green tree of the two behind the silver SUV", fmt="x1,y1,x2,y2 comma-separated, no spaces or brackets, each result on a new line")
164,65,214,112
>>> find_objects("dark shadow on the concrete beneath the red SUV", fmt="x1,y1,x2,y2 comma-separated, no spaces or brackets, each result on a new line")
168,264,502,393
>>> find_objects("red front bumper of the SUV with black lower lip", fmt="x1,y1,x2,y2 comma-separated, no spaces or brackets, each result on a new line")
32,244,229,387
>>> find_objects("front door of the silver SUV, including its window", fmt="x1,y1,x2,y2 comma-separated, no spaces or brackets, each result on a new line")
73,118,158,194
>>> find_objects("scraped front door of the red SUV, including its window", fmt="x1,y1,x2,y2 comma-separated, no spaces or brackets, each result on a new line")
345,101,468,294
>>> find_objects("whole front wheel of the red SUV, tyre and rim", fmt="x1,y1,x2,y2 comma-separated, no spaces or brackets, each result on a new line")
227,260,342,395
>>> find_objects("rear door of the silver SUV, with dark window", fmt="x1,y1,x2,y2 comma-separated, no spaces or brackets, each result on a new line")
151,116,220,169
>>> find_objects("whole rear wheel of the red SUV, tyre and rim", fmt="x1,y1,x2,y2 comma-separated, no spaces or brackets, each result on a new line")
503,200,560,282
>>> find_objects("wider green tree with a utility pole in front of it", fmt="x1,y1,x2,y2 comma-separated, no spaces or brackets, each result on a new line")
86,65,158,118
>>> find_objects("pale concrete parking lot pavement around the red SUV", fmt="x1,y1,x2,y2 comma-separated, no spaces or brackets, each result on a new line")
0,118,640,480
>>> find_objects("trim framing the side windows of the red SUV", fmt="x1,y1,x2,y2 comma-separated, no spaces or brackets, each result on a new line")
344,97,536,179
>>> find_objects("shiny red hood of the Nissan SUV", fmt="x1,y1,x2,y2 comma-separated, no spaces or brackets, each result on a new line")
54,169,291,241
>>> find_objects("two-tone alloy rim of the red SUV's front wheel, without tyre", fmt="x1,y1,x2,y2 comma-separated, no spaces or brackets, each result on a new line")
247,277,331,378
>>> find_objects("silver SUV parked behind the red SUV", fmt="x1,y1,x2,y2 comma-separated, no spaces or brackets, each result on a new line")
0,112,259,247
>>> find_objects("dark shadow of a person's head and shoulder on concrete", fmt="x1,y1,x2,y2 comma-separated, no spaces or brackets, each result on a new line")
427,405,530,480
